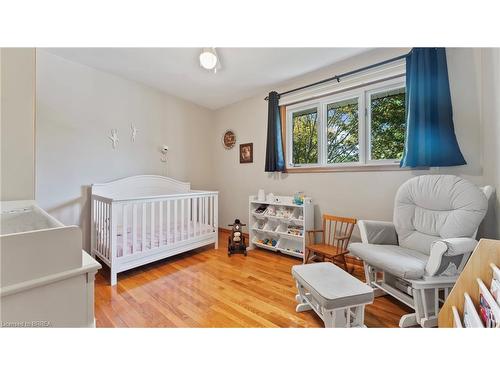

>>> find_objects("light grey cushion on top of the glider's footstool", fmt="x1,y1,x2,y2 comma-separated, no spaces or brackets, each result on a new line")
292,262,373,310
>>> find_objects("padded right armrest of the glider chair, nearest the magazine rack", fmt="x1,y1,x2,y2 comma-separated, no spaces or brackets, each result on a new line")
425,237,477,276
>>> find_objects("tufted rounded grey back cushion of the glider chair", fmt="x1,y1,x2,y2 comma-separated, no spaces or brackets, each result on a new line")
394,175,488,255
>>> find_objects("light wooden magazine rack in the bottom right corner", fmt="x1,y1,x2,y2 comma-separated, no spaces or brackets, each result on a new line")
438,239,500,328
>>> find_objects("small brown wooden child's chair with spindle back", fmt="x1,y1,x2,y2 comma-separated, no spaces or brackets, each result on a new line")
304,215,357,271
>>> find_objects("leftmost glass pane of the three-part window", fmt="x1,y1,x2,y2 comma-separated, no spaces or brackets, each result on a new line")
292,108,318,164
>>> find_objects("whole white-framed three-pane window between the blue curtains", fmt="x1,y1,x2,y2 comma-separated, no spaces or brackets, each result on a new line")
286,77,406,169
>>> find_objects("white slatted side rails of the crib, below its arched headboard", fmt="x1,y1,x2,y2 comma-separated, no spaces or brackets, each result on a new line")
92,191,218,265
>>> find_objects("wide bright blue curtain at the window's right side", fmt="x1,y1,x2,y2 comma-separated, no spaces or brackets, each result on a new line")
400,48,466,167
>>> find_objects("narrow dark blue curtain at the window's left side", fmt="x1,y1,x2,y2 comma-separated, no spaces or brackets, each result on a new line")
265,91,285,172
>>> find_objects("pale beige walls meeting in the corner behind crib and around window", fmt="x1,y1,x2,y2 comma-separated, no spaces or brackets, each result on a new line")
25,49,500,256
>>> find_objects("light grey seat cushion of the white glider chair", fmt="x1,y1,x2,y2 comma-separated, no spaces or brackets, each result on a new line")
349,243,429,279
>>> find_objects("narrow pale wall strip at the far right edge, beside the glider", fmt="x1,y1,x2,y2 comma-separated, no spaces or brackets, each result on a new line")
482,48,500,238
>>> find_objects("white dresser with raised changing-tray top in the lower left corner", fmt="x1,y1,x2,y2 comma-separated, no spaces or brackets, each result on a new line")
0,201,101,327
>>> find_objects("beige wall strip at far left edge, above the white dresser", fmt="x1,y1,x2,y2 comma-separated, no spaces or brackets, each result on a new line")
0,48,35,200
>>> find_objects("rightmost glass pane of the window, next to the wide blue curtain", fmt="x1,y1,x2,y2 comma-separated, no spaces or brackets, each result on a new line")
370,88,406,160
